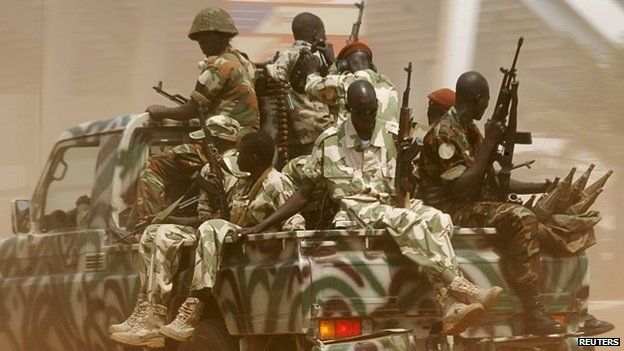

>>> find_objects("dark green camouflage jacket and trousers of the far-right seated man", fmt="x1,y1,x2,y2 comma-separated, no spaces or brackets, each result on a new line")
418,108,539,284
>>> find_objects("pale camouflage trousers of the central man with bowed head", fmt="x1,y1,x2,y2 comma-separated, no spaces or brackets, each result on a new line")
341,199,459,288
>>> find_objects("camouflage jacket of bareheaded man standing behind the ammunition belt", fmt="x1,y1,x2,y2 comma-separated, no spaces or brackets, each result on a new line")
266,40,334,145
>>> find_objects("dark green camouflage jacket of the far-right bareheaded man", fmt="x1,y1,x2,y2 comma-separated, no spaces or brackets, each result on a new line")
418,107,492,212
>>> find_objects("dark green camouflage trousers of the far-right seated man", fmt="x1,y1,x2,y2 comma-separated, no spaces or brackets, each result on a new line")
452,201,540,286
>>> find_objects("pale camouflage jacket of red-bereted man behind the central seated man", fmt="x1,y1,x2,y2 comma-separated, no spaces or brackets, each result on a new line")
306,69,399,134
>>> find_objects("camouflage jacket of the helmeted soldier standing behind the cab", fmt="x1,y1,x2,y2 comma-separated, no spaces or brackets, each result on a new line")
195,47,260,135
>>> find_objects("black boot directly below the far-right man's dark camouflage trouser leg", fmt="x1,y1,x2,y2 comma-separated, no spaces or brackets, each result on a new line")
521,289,566,335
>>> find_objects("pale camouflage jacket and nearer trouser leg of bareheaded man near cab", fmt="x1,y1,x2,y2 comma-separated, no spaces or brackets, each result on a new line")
191,167,305,290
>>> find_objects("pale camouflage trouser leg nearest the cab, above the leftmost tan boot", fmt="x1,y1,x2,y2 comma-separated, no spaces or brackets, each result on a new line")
139,224,197,304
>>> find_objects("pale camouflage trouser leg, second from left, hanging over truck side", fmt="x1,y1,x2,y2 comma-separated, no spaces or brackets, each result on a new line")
191,219,241,291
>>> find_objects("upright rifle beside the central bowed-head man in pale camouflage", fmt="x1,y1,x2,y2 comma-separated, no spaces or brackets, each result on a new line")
394,62,412,208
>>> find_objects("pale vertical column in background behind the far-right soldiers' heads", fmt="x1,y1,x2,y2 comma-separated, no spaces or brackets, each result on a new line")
436,0,481,88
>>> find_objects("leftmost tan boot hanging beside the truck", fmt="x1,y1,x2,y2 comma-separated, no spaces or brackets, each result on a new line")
111,305,167,348
